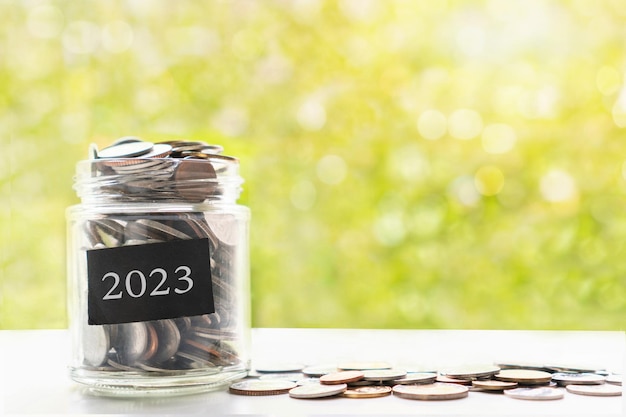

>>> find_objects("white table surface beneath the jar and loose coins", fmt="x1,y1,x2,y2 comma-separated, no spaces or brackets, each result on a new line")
0,329,626,417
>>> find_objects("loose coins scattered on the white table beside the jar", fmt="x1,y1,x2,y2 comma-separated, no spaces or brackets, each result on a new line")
230,362,621,401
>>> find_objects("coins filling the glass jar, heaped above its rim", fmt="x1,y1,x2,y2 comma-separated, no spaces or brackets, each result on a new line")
80,137,243,374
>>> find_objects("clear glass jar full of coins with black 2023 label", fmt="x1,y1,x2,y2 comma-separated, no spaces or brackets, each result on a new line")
67,138,250,396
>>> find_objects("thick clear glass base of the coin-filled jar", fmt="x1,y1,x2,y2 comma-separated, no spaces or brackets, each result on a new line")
70,368,248,397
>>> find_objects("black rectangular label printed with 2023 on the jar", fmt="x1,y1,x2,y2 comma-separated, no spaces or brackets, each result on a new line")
87,239,215,324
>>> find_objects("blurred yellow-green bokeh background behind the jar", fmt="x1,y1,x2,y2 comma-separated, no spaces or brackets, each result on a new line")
0,0,626,329
